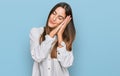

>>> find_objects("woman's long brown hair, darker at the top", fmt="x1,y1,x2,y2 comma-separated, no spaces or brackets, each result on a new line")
39,2,76,58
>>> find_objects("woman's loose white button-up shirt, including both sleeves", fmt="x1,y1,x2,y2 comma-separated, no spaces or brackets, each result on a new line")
30,27,74,76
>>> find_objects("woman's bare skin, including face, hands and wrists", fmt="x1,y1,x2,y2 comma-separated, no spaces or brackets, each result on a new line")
48,7,71,47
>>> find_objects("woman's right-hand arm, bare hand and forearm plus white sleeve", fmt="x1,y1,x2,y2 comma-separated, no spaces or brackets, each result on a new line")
57,16,74,68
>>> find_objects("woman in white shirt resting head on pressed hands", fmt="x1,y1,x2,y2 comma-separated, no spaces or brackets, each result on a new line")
30,2,75,76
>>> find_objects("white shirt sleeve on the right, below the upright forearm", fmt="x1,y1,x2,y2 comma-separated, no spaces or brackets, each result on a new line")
57,42,74,68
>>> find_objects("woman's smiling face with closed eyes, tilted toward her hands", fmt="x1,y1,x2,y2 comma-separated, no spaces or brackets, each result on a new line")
48,7,66,28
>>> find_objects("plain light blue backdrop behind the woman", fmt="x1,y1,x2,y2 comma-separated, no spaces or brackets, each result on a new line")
0,0,120,76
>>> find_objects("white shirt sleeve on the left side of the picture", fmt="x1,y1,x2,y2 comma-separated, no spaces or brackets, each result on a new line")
30,28,56,62
